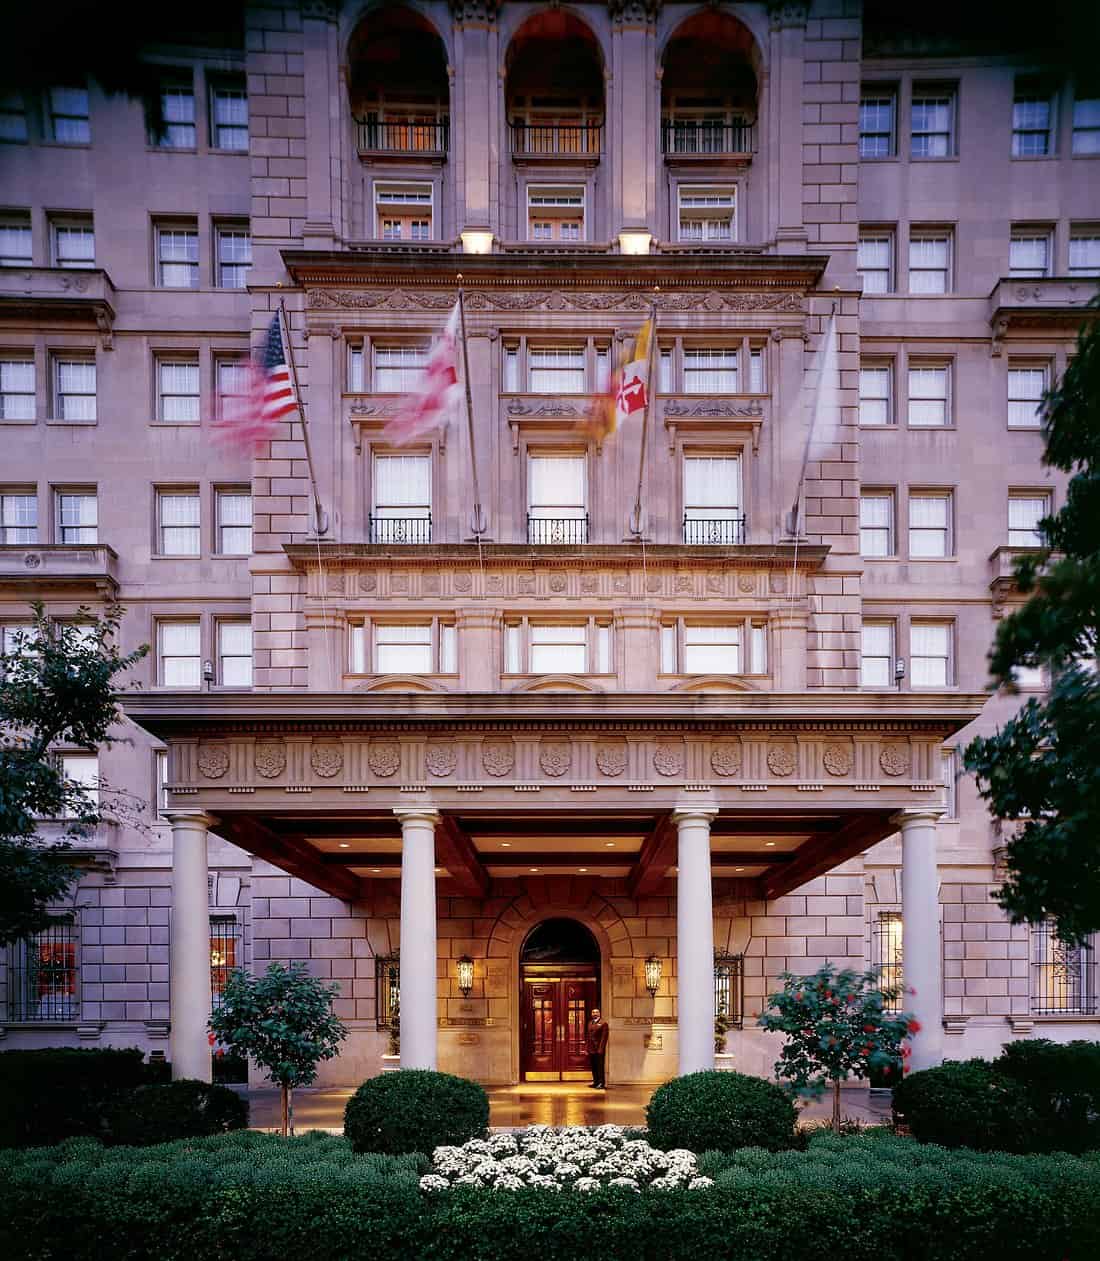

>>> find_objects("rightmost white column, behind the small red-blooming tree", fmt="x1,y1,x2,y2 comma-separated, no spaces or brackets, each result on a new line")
891,810,944,1072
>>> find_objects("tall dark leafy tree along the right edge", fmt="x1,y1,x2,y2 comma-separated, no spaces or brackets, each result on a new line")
964,301,1100,944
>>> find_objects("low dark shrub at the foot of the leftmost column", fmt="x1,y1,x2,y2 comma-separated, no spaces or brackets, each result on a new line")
106,1079,249,1148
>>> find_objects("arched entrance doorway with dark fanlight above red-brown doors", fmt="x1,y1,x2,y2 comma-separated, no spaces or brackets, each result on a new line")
520,919,599,1082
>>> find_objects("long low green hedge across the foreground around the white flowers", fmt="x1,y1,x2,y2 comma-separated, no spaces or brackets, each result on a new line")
0,1131,1100,1261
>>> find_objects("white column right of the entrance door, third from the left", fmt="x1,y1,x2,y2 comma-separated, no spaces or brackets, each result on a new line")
672,807,718,1077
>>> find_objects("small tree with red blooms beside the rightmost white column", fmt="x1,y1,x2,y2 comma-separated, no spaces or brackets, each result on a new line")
759,963,921,1132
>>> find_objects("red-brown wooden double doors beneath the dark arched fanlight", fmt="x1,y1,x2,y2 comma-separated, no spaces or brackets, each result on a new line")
520,966,599,1082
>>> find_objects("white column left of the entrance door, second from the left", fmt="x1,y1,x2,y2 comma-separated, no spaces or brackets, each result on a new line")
394,808,439,1068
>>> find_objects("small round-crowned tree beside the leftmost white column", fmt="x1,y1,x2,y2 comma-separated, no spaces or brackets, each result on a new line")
209,963,348,1137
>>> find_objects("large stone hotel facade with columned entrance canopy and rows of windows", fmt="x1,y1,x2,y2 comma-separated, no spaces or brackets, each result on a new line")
0,0,1100,1083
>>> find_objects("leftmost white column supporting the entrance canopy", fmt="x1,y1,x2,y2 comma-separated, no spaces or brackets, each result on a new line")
168,811,216,1082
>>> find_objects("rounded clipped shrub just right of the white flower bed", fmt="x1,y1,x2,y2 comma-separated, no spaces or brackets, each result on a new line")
646,1072,797,1153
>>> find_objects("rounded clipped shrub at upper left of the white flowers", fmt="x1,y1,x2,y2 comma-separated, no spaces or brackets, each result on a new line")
344,1068,489,1155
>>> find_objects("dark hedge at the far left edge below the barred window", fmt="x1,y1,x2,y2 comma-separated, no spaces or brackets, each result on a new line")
0,1048,155,1148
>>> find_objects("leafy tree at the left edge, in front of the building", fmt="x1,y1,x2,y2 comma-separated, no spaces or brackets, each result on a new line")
0,603,149,944
